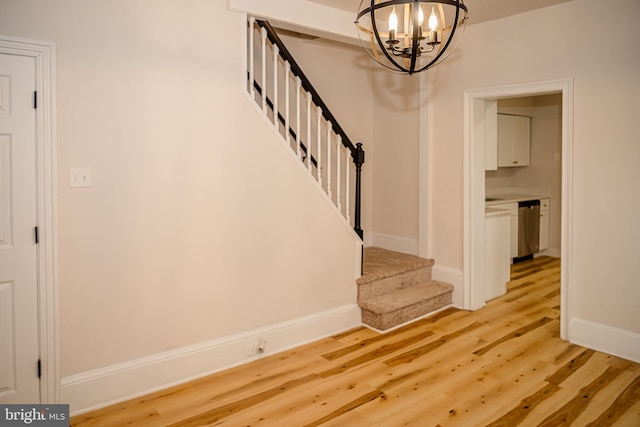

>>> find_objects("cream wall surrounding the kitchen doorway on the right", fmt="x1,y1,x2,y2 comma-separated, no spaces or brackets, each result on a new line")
424,0,640,358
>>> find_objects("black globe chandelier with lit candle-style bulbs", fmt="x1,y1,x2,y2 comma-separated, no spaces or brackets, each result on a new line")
355,0,469,75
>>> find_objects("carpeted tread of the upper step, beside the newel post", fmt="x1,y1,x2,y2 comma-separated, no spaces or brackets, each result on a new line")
356,247,434,285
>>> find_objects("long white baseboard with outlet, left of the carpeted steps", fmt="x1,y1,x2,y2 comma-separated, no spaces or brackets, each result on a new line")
61,304,362,415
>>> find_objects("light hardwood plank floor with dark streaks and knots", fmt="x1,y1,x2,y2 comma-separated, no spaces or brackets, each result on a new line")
71,257,640,427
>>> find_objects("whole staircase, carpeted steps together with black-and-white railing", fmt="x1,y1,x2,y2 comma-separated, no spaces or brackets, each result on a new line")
246,17,453,330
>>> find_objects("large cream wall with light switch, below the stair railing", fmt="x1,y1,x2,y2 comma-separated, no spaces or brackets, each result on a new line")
0,0,359,411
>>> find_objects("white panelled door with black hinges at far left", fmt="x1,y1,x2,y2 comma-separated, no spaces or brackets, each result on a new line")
0,54,40,404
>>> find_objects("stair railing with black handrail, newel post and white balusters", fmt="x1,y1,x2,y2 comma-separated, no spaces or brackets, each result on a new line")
247,17,364,239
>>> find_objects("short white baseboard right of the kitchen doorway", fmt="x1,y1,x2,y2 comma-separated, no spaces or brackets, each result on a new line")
569,318,640,363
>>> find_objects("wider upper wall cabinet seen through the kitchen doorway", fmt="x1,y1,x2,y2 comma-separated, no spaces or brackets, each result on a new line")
498,114,531,167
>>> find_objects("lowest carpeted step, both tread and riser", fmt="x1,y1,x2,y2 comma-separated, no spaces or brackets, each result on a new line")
359,281,453,331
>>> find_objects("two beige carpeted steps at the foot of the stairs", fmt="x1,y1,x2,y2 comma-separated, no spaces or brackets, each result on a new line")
356,247,453,331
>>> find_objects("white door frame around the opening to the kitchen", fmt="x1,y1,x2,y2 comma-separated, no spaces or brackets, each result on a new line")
463,79,573,339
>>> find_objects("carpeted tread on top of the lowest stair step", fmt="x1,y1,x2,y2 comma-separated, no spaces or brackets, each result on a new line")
359,280,453,314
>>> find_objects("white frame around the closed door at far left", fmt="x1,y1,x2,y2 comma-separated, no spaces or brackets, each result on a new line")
0,35,60,404
